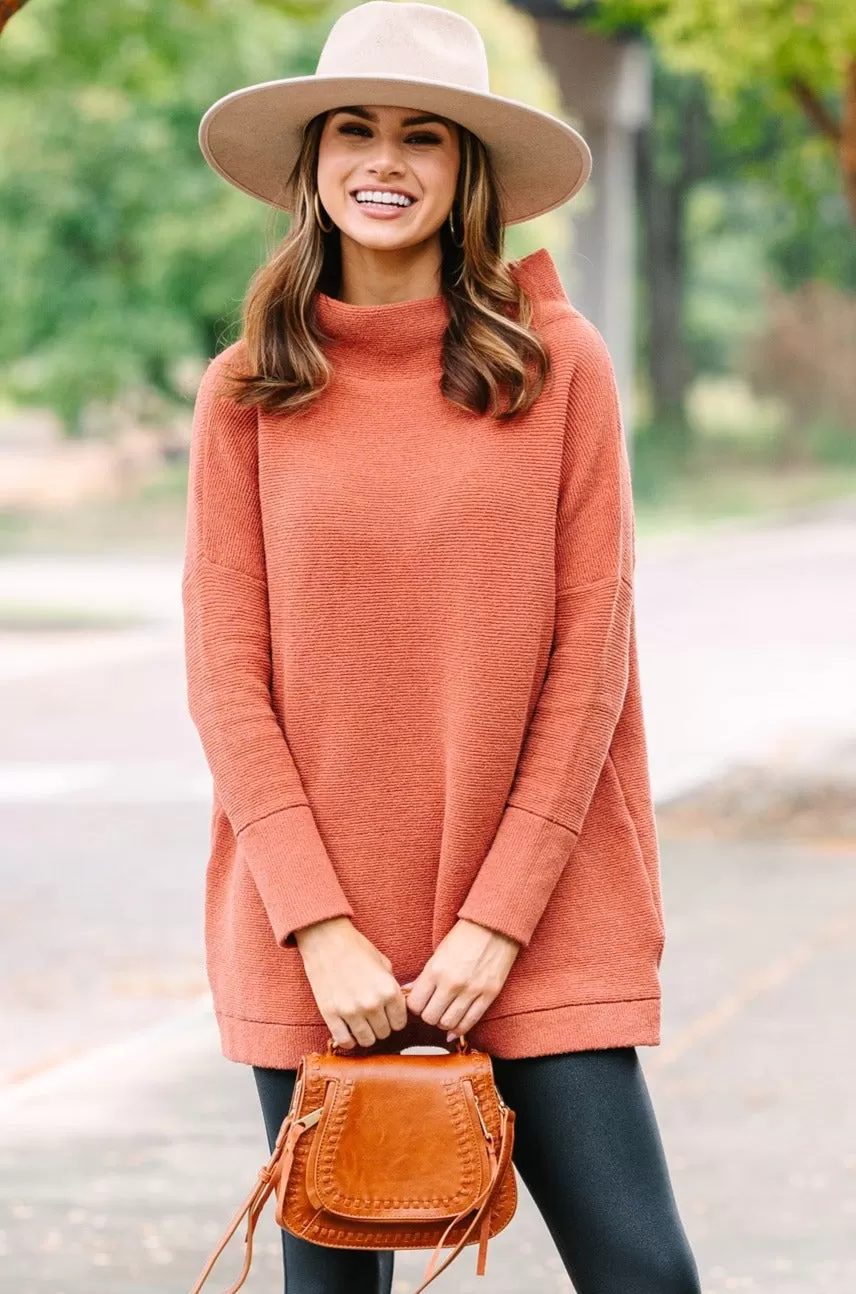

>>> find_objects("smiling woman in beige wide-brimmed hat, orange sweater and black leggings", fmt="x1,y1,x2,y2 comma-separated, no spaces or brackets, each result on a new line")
182,0,700,1294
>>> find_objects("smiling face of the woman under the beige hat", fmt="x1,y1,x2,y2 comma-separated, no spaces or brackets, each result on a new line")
318,106,460,251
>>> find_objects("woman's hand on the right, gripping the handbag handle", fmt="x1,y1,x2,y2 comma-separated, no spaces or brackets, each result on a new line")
407,920,520,1034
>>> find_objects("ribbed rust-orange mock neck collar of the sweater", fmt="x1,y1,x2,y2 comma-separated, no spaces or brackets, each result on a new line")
316,247,566,379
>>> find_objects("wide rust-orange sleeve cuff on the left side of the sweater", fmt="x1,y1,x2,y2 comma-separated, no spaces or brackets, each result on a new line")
238,805,353,949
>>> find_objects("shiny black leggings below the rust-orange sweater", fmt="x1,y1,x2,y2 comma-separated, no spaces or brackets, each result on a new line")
253,1047,701,1294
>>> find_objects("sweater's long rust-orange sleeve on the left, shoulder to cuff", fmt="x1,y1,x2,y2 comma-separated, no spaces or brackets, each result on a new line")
181,347,353,947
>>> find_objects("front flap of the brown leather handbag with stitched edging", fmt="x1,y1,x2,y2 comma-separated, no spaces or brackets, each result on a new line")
306,1055,490,1223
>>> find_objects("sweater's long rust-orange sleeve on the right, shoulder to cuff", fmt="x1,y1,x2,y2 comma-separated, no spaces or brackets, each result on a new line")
458,320,635,945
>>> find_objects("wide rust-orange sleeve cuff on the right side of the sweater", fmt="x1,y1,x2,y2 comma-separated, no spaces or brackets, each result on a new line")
458,805,577,946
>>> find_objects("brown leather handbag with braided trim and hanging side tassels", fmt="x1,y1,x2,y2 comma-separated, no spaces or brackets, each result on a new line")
191,1038,517,1294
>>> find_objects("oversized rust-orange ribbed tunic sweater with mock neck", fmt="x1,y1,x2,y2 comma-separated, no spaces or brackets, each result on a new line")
182,248,663,1068
